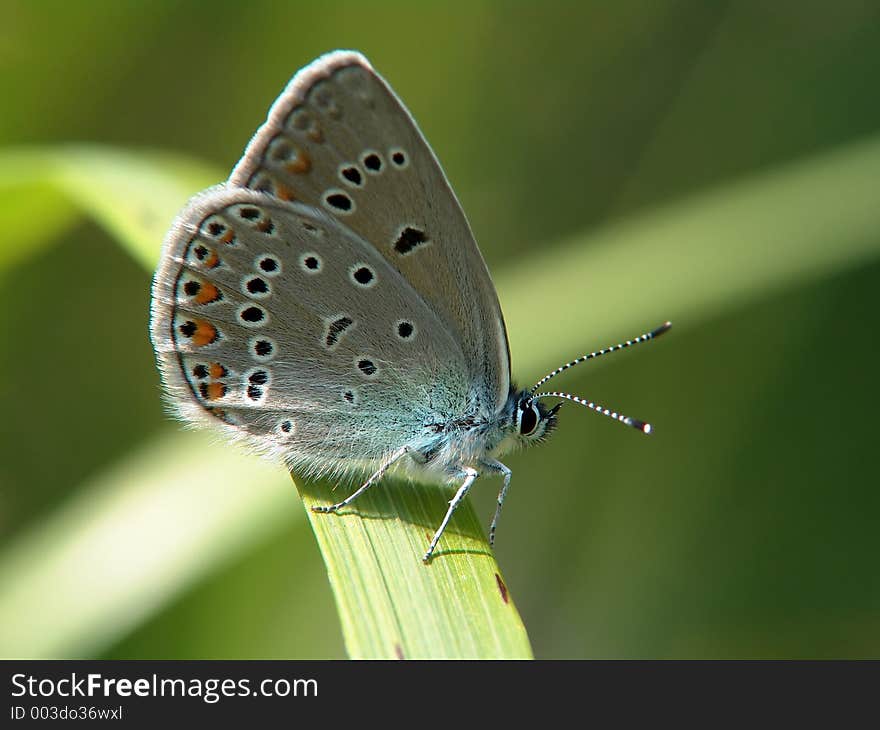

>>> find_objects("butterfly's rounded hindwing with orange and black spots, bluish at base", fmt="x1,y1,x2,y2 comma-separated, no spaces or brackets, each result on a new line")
151,186,470,470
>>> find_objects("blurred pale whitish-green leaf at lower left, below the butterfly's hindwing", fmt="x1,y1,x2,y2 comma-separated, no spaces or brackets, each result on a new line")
0,433,301,659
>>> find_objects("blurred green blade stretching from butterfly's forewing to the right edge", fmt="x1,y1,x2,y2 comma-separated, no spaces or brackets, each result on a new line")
498,138,880,373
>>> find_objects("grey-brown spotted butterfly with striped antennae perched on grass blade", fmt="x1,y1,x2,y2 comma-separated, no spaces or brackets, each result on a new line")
150,51,670,562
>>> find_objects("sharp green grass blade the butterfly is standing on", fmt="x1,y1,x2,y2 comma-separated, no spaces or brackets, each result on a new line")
300,481,532,659
